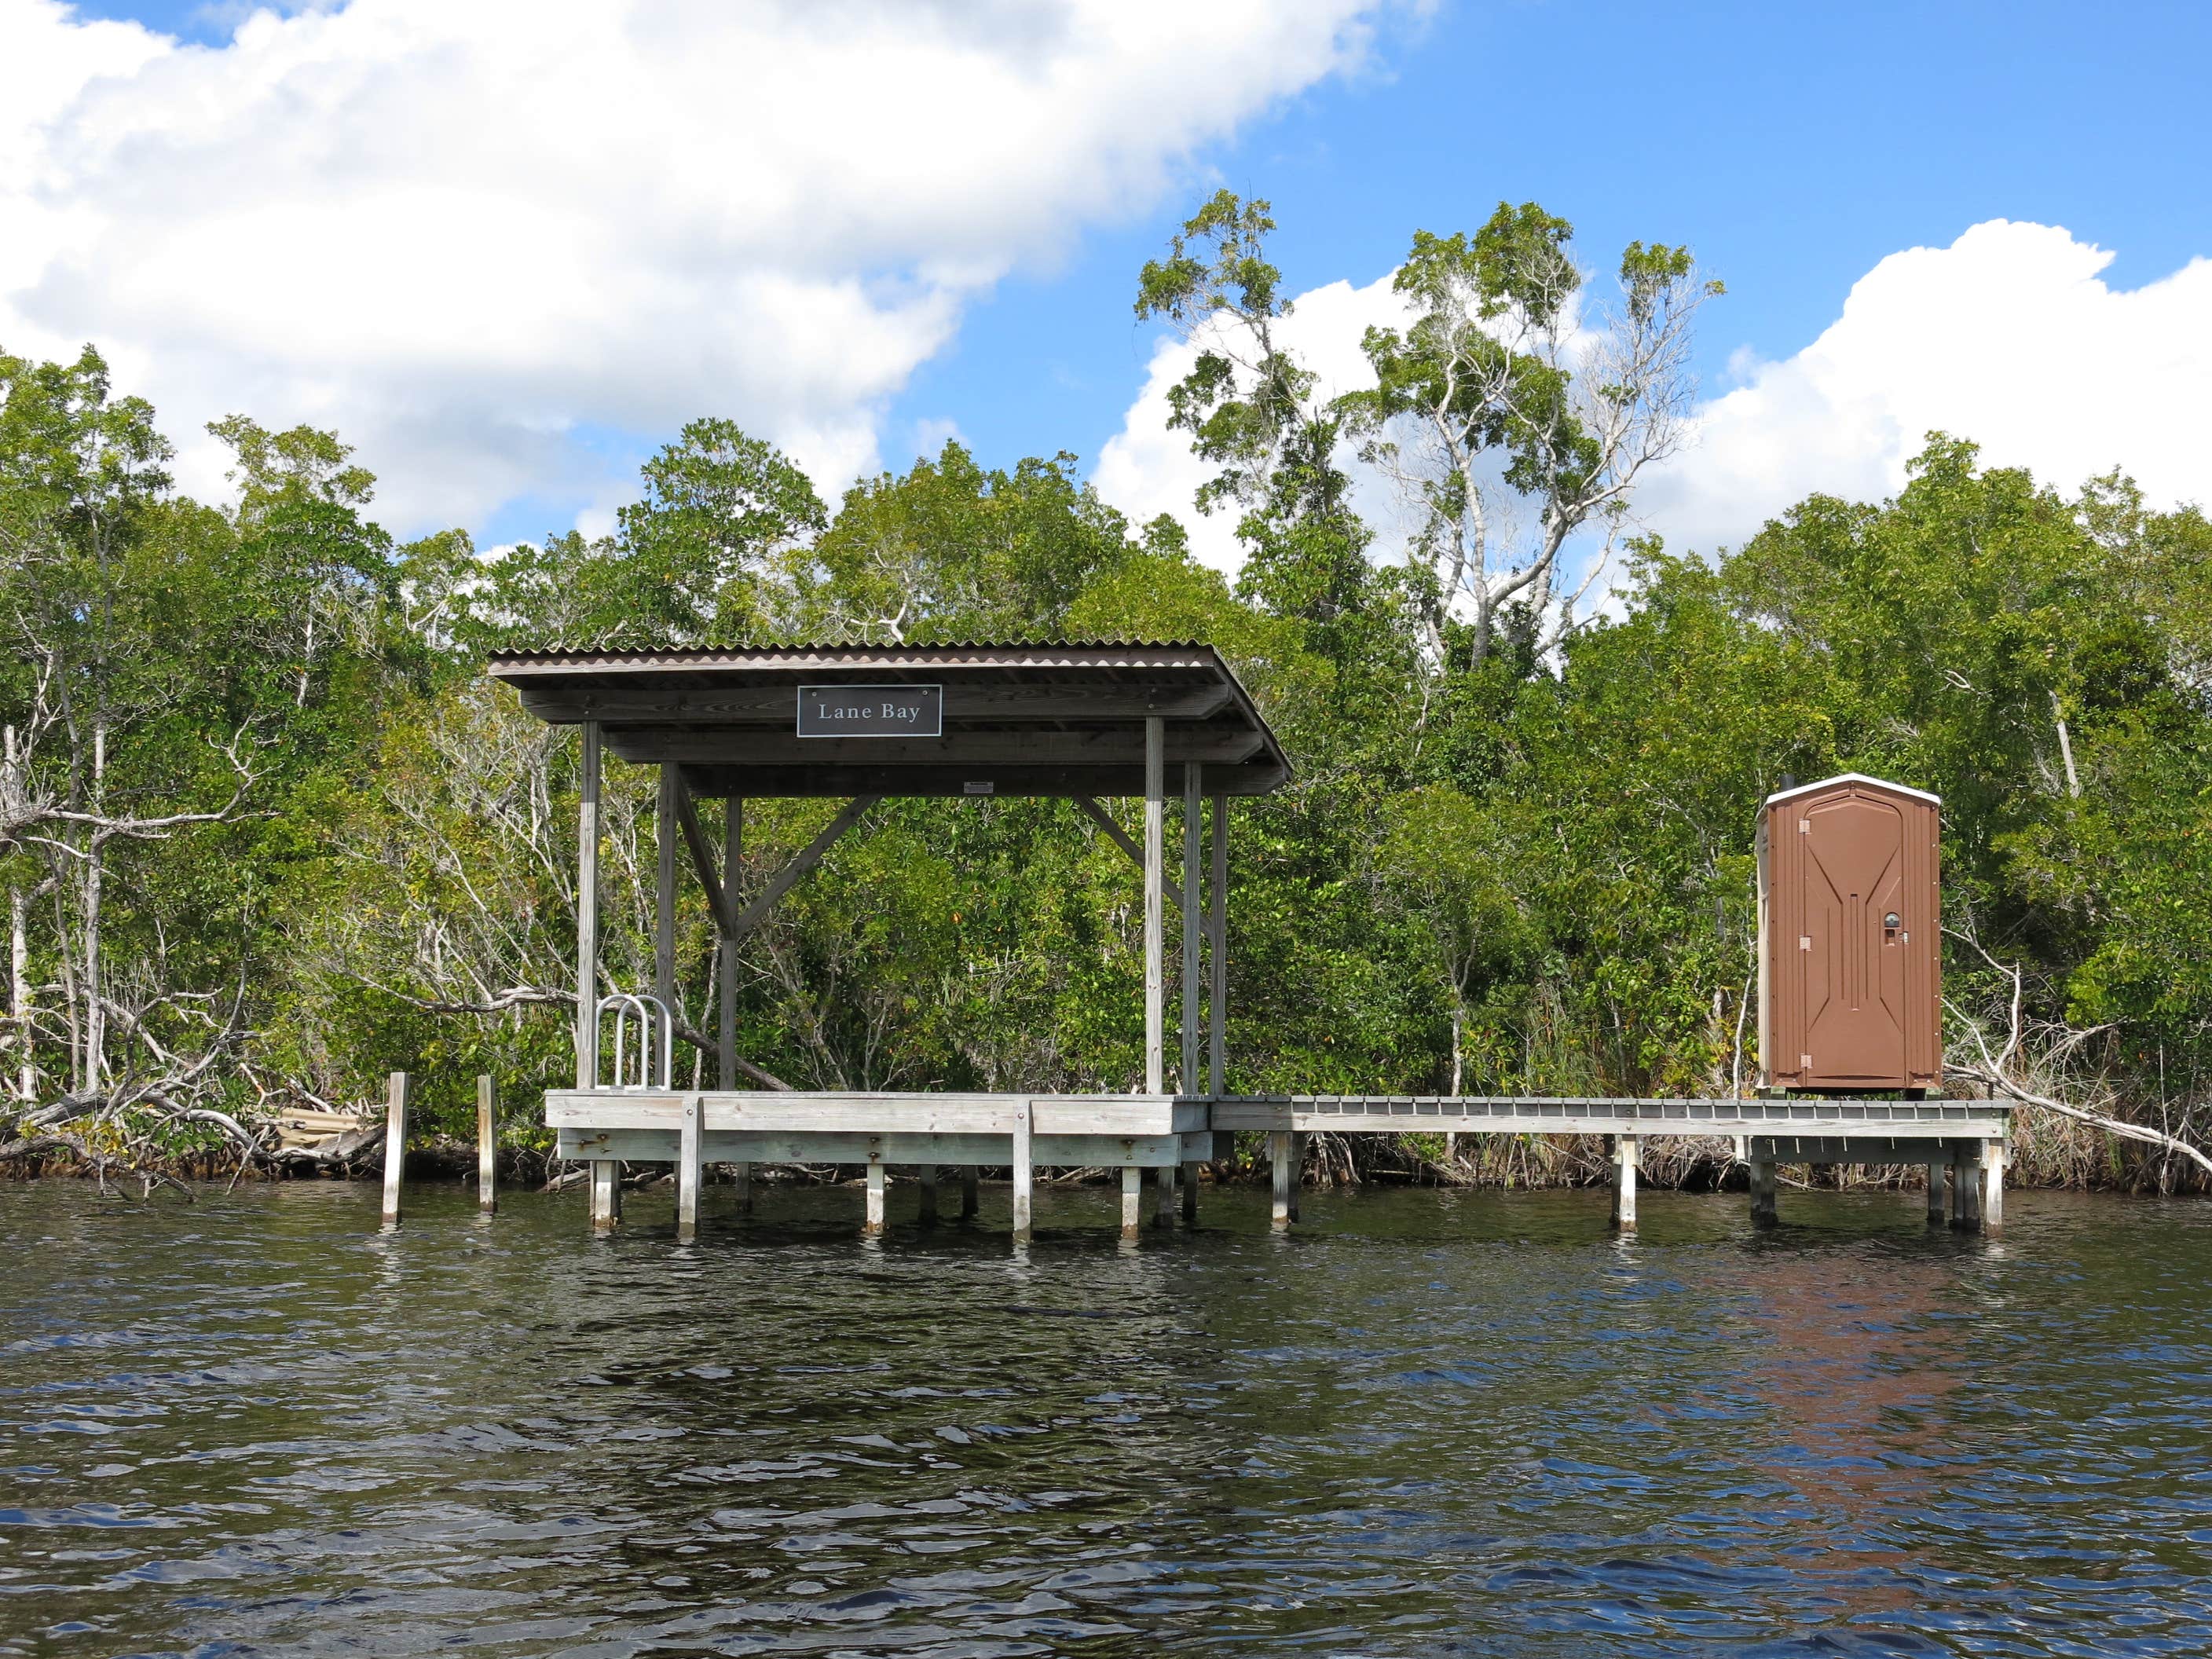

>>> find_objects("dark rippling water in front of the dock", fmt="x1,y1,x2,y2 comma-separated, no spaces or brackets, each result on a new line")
0,1181,2212,1657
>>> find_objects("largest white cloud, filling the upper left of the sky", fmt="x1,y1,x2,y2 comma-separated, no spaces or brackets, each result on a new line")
0,0,1378,526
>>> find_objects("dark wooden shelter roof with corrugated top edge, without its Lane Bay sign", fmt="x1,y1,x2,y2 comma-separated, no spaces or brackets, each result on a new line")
487,642,1290,797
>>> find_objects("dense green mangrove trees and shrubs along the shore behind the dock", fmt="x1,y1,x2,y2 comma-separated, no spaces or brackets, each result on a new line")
0,192,2212,1192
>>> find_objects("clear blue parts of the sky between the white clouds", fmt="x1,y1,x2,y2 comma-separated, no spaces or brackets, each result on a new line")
17,0,2212,562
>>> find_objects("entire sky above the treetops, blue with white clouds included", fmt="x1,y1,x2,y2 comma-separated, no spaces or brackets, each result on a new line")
0,0,2212,566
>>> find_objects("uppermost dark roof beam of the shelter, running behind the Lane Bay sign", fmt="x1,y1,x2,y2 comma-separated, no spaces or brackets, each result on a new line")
502,672,1234,730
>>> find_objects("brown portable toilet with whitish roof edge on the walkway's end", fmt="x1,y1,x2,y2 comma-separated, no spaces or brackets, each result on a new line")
1759,772,1942,1095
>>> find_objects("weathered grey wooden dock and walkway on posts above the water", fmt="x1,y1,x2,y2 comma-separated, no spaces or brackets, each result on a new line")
547,1088,2011,1234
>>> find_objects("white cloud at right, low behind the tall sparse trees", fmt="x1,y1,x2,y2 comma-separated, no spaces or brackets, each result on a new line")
1097,219,2212,584
